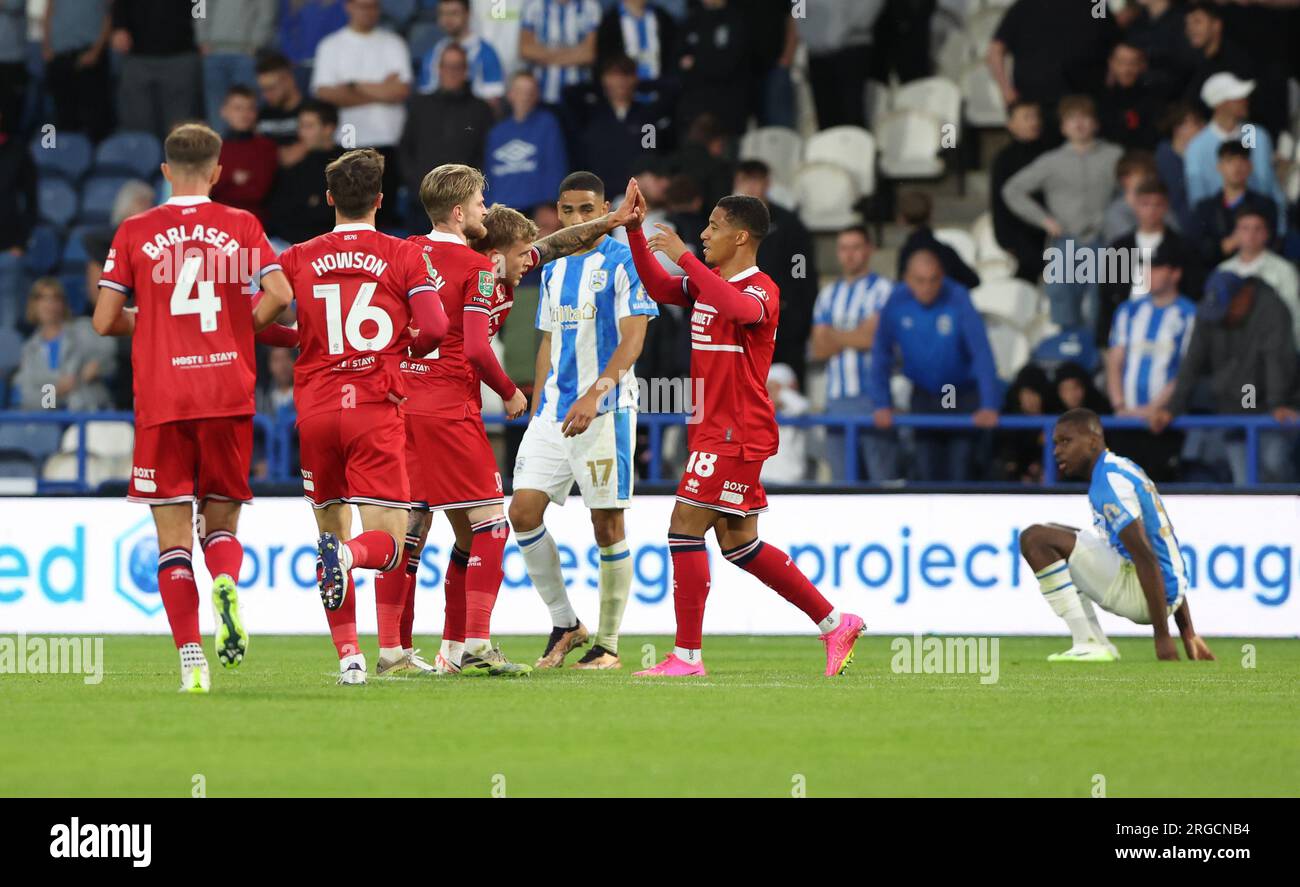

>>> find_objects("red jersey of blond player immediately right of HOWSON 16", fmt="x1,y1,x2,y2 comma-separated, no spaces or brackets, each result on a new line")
402,232,514,419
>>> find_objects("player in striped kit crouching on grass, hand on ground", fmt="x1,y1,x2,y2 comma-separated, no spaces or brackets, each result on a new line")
1021,410,1214,662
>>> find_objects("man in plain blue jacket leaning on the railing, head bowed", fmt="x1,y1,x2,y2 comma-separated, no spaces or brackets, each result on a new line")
871,250,1002,481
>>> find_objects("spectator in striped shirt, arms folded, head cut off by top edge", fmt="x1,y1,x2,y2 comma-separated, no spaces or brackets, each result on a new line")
519,0,601,104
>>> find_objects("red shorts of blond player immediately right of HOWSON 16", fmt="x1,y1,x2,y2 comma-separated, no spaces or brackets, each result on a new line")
406,414,506,511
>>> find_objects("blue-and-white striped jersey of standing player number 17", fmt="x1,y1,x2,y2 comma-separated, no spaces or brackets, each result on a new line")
537,237,659,421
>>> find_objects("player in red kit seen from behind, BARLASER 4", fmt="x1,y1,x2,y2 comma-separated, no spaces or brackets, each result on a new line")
94,124,293,693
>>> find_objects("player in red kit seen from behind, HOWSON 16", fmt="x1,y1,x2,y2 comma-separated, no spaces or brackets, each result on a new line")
280,148,447,684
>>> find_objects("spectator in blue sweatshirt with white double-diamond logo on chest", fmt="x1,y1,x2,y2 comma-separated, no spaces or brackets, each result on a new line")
485,72,568,212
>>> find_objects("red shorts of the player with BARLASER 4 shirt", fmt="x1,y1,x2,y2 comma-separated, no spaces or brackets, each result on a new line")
126,416,252,505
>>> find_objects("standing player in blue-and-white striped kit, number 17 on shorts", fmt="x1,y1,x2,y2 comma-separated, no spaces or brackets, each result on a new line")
510,172,659,669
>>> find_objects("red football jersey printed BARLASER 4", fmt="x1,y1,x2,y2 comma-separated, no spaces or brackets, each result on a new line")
99,196,280,428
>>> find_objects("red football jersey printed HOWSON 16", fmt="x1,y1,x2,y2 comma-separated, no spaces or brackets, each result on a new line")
280,224,434,421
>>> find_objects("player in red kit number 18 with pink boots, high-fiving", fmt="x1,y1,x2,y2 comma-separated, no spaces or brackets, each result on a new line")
628,183,863,678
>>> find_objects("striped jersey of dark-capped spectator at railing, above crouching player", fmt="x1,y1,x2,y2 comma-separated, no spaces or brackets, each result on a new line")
1110,295,1196,407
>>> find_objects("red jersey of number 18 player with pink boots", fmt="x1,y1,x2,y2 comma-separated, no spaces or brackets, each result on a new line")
683,267,781,460
